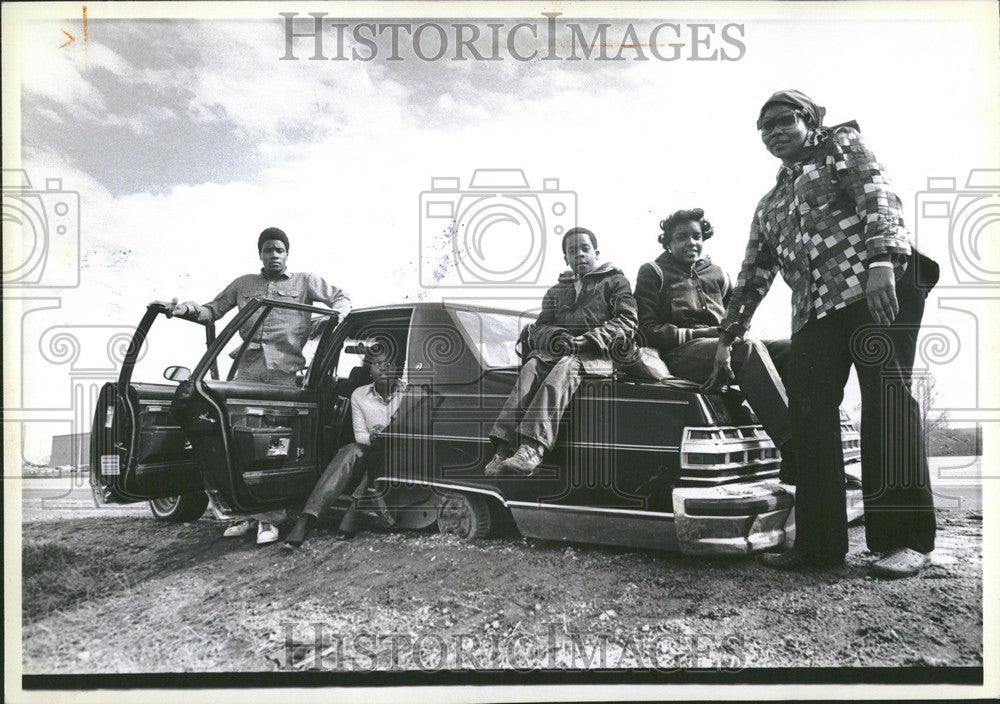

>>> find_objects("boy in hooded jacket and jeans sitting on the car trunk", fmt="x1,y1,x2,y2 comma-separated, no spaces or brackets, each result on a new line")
485,227,638,476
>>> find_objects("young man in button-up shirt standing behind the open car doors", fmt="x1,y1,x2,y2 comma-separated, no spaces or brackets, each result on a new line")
164,227,351,545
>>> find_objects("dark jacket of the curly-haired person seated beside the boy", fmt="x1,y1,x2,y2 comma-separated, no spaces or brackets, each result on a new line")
635,252,732,353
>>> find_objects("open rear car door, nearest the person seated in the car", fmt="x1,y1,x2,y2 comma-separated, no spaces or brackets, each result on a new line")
173,299,336,514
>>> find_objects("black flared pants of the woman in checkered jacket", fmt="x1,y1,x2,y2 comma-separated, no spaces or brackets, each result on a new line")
786,255,936,560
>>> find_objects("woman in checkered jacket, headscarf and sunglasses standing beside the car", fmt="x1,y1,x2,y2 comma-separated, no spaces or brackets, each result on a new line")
710,90,937,577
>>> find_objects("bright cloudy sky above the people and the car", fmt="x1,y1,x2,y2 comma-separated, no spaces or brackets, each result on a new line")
5,4,1000,460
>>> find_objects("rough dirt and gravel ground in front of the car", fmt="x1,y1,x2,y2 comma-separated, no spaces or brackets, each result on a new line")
23,510,983,674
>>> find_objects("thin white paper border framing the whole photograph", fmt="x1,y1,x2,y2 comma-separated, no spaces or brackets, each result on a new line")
2,1,1000,704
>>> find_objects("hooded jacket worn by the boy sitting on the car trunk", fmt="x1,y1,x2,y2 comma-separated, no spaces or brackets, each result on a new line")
528,262,639,374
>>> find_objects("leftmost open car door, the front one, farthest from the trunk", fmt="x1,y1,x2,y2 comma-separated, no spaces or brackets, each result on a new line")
90,303,218,503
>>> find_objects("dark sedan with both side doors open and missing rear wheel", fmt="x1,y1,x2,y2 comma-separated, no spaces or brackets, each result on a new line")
91,299,860,554
